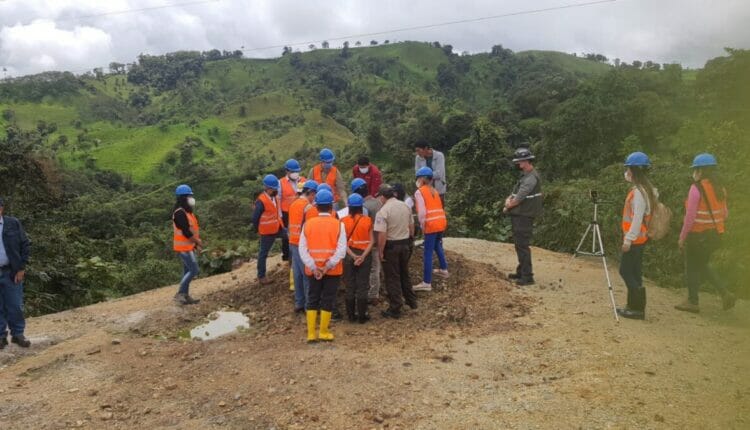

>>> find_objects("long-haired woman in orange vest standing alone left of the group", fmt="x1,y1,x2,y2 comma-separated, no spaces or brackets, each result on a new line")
172,184,203,305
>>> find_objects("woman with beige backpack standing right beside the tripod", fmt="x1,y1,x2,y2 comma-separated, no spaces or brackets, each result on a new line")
617,152,658,320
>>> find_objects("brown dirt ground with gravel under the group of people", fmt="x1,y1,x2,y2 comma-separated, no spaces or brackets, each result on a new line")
0,239,750,429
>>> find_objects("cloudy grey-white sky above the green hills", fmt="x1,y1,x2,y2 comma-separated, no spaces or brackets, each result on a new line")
0,0,750,76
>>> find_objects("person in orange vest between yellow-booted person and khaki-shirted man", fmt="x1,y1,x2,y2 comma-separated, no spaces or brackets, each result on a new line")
341,194,375,324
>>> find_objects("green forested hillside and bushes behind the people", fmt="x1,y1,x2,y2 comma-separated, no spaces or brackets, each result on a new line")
0,42,750,313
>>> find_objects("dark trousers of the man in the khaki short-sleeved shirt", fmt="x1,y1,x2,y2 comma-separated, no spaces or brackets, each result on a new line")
383,241,417,312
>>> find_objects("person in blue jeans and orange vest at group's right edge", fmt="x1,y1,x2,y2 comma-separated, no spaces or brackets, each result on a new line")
412,167,448,291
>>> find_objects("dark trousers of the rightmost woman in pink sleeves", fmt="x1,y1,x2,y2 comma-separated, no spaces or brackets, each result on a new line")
685,230,727,305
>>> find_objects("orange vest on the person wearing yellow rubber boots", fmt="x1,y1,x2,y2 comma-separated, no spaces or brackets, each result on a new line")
302,216,344,276
